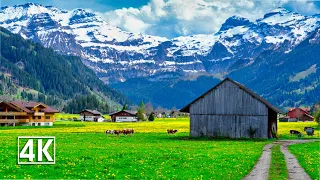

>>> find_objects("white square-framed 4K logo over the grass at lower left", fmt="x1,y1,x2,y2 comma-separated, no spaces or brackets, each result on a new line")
18,136,56,164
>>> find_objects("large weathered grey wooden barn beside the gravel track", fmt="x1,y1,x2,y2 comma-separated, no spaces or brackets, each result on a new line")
180,78,280,138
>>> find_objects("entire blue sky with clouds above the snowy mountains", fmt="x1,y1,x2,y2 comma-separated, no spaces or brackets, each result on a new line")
1,0,320,38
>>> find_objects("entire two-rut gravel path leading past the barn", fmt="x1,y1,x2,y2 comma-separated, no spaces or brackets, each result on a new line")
244,140,315,180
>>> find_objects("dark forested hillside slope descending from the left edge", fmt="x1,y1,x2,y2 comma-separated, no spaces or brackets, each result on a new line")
0,27,126,109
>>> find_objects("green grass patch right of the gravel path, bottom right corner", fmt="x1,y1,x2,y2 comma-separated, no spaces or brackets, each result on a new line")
289,142,320,180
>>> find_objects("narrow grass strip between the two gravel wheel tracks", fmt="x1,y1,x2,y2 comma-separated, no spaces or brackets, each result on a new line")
269,144,288,180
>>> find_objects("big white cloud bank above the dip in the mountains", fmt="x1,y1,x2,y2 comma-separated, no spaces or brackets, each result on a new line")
101,0,319,37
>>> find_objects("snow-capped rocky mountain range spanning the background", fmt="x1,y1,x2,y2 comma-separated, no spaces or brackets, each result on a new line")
0,3,320,108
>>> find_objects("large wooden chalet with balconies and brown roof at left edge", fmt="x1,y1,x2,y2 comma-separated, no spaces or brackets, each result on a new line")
0,101,59,126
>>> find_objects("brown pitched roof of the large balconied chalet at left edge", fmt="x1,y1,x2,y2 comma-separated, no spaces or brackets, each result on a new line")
5,101,59,113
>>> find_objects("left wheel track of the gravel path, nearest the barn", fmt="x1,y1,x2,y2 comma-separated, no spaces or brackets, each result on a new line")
244,144,274,180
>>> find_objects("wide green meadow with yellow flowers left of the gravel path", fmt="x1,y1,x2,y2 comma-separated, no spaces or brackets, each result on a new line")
0,116,314,179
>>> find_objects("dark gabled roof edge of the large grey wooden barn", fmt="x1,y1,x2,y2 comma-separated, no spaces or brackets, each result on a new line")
180,77,281,113
